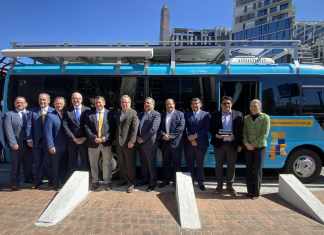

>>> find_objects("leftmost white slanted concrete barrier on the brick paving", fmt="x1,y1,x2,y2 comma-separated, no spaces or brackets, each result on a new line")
35,171,89,227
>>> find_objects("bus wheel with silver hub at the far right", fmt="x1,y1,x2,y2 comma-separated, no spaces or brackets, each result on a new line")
287,149,322,183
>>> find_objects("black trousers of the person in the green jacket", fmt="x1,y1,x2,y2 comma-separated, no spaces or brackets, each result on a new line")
245,148,265,196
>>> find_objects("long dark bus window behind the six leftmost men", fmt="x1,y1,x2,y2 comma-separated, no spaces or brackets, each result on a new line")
9,75,144,110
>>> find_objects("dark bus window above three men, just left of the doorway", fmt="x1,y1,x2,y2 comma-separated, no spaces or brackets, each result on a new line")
149,77,216,112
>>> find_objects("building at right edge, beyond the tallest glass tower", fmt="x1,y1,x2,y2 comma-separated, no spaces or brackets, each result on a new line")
294,21,324,45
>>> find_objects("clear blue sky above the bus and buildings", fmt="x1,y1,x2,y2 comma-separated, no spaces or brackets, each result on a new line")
0,0,324,48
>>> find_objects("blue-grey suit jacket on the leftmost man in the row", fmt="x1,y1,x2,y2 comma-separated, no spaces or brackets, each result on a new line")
4,111,31,146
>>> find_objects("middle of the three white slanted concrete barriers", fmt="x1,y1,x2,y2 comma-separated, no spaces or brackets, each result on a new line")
176,172,201,229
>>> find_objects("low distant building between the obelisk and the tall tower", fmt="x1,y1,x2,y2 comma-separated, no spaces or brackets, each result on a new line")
171,27,231,46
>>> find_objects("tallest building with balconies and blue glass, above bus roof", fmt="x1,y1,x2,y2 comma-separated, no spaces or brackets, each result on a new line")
232,0,295,40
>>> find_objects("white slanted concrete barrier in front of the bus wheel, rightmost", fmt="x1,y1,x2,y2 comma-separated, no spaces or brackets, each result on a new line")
279,174,324,224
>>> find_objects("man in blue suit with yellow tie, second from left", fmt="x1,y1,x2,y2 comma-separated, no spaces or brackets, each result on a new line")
27,93,54,189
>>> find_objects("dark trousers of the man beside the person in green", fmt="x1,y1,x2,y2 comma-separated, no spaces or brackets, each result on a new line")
215,143,237,186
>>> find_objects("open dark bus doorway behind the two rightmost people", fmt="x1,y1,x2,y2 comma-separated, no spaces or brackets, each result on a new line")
219,81,260,164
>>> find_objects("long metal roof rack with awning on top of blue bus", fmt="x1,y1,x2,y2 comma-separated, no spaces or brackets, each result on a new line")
1,40,300,70
